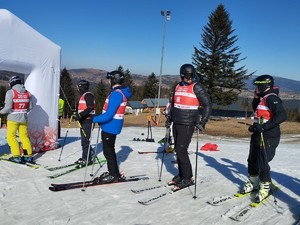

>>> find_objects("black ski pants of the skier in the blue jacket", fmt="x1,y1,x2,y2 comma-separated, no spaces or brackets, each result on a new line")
101,130,120,177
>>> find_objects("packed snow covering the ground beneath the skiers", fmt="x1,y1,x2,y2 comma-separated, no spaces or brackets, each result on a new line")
0,127,300,225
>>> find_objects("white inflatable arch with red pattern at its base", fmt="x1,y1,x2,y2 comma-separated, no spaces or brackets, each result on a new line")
0,9,61,152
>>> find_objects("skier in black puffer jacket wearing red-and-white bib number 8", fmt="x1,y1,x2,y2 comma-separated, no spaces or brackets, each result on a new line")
168,64,211,189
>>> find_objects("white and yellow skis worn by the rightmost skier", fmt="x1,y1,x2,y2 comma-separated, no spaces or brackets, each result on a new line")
207,185,279,221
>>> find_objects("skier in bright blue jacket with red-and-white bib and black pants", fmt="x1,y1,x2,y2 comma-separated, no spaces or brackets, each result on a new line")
93,70,131,183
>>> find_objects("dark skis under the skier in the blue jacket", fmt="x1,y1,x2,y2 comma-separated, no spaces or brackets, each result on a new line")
49,174,149,192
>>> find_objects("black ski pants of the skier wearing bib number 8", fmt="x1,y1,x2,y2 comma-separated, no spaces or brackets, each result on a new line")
173,124,195,179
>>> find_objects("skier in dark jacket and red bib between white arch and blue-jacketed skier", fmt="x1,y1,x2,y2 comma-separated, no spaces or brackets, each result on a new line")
74,80,96,168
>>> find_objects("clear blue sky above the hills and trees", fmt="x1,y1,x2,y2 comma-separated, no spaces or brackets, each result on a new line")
0,0,300,80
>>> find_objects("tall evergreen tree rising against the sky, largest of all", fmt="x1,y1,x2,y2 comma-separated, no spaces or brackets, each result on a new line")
192,4,253,105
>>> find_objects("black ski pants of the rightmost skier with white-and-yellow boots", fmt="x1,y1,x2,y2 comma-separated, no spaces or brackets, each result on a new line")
248,133,280,182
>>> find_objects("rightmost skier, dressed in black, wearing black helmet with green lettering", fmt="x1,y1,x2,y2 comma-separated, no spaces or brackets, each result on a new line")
241,75,287,202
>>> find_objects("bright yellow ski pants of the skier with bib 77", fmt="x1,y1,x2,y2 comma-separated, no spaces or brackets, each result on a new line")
6,120,32,157
